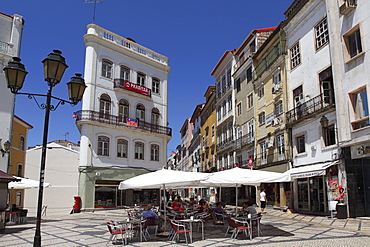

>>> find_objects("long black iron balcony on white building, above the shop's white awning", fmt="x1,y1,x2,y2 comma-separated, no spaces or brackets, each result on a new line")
286,93,335,124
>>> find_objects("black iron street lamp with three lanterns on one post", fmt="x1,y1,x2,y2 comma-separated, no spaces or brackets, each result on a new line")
4,50,86,247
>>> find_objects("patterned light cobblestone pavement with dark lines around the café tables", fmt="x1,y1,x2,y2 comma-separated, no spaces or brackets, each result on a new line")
0,209,370,247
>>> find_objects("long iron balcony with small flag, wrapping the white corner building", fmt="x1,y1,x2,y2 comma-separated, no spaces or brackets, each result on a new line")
76,110,172,136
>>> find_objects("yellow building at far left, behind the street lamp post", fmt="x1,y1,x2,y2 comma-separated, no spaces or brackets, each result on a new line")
8,116,33,208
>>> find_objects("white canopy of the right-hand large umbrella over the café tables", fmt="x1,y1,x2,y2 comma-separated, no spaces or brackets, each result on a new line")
201,167,282,187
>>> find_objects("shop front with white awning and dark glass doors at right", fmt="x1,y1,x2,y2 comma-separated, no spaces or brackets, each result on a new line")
290,162,340,215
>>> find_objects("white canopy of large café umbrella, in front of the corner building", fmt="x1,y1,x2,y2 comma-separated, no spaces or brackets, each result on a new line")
119,169,211,190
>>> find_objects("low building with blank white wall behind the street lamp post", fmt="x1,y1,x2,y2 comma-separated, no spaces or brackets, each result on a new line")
24,140,79,216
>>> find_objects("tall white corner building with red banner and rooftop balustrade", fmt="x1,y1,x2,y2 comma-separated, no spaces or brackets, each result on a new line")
77,24,172,209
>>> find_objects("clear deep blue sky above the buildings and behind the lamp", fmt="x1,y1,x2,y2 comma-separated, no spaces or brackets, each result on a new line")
0,0,293,153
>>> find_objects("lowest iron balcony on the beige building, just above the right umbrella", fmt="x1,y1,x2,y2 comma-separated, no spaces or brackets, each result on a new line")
253,148,290,168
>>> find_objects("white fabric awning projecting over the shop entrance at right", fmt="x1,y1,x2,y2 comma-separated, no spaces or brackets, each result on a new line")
287,160,339,179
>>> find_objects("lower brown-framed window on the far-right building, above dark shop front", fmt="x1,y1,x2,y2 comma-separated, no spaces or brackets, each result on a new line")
349,88,370,130
